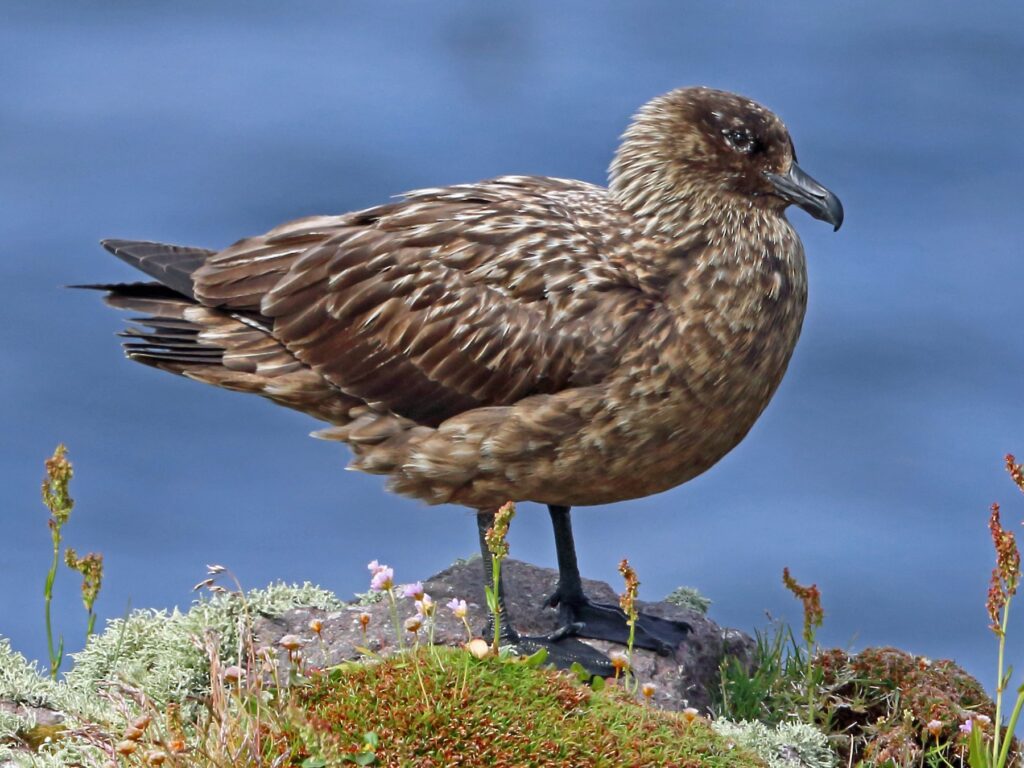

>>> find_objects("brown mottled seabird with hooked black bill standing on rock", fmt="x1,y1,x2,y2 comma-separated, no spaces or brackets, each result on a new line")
83,88,843,668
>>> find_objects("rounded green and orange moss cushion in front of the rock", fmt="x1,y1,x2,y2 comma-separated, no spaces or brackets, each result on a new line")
282,649,761,768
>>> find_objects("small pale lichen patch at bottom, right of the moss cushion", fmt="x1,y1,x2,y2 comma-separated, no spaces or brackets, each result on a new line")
712,720,837,768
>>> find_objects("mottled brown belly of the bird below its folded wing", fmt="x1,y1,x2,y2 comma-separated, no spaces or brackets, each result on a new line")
417,370,777,509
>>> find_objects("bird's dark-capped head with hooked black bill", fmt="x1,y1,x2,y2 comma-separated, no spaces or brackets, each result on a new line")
609,88,843,229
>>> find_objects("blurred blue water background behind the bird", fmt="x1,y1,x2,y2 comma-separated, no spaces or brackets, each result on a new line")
0,0,1024,687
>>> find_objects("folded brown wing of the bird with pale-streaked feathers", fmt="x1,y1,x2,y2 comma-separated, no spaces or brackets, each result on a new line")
194,177,660,425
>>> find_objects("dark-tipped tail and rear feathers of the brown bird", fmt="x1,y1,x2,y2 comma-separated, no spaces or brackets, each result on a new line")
79,240,428,483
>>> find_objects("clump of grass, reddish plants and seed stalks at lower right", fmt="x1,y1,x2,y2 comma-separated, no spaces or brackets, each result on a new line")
717,456,1024,768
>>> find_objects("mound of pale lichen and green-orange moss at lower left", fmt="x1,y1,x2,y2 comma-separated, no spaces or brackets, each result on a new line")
0,587,760,768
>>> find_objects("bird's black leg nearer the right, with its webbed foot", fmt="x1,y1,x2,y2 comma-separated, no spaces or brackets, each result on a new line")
547,505,690,654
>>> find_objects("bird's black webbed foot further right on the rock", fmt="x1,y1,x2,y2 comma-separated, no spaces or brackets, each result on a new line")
546,590,691,656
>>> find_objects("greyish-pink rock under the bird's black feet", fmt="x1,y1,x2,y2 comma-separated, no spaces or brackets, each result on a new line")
254,559,754,712
